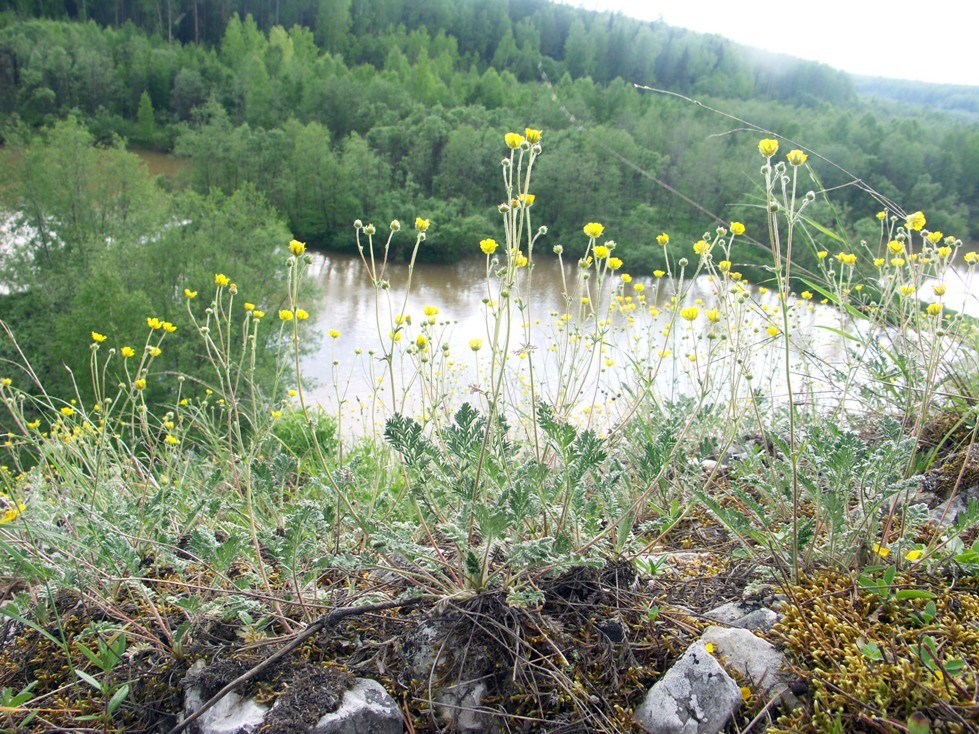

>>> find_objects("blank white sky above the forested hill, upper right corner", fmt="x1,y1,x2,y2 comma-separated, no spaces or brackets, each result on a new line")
561,0,979,86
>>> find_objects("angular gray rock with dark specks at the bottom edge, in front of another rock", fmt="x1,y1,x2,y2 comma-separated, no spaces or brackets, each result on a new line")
635,640,743,734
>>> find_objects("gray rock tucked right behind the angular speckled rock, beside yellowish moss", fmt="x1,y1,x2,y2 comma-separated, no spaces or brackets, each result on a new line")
700,627,798,706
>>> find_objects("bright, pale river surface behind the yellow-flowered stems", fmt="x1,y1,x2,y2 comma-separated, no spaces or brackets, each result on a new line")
303,253,976,440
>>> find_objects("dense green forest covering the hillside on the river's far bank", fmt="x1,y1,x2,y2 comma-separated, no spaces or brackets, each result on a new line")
0,0,979,268
